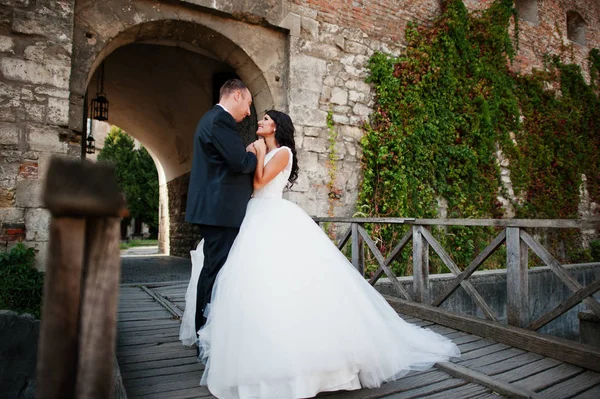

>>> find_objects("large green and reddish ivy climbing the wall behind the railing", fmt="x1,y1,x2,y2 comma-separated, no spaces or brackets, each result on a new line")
359,0,600,272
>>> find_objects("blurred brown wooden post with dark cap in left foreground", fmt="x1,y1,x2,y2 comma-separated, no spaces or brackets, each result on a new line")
36,158,125,399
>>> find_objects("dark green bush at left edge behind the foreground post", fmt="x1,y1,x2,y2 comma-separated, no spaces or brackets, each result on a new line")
0,243,44,318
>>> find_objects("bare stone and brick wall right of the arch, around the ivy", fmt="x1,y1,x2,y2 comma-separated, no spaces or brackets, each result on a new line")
284,0,600,220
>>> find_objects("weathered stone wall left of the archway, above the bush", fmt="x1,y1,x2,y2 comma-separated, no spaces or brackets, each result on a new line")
0,0,80,267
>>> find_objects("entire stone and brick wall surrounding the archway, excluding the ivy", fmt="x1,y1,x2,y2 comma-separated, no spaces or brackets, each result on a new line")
0,0,600,263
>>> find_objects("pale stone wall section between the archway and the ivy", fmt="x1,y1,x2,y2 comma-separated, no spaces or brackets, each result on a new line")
286,2,402,216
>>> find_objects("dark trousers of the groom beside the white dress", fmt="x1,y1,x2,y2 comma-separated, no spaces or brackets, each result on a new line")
196,225,240,332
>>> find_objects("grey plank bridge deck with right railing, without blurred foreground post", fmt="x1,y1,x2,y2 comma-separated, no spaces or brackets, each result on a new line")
117,218,600,399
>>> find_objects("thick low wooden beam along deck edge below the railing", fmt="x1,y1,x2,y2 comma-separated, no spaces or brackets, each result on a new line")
384,296,600,372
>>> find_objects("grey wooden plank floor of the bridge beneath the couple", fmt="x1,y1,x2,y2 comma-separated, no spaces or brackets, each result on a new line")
117,283,600,399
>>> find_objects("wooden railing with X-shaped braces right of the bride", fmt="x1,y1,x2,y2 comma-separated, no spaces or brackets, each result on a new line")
314,218,600,331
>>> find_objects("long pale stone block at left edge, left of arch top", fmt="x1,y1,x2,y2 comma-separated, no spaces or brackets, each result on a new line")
0,58,71,89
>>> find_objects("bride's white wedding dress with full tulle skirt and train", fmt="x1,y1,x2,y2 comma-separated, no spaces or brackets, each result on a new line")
180,147,460,399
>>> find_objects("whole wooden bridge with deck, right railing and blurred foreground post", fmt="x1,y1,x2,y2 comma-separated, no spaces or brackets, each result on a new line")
36,160,600,399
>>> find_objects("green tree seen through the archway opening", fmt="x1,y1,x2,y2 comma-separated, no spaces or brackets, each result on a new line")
98,127,158,237
